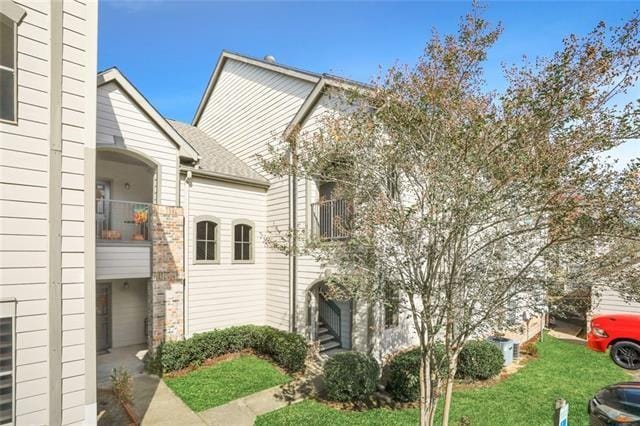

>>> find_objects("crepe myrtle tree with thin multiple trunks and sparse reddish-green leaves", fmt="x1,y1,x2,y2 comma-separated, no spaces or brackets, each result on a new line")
262,5,640,425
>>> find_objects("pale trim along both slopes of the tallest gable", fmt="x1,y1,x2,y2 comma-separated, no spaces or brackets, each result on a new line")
191,50,321,126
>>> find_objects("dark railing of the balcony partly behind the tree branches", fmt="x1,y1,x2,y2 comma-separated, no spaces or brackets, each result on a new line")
311,200,351,240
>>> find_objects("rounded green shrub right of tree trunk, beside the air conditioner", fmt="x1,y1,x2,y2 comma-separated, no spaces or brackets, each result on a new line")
456,340,504,380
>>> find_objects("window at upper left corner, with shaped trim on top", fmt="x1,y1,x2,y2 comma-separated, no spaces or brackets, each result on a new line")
0,0,25,123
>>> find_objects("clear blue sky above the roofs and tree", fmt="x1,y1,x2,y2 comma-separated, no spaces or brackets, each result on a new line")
98,0,640,167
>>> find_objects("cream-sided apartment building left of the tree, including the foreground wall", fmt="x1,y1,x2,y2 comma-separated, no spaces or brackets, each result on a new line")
0,16,552,424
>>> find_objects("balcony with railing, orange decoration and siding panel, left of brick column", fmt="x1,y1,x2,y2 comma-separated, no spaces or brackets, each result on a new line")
96,199,153,280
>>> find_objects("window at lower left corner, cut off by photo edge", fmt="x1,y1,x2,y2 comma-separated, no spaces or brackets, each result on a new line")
0,300,15,425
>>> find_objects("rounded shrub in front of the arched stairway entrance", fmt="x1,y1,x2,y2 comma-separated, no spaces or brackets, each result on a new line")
324,352,380,401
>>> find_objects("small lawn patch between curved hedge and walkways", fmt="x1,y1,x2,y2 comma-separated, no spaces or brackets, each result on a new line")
164,355,291,411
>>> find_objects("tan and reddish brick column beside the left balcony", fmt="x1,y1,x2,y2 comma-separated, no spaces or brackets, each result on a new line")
147,204,184,349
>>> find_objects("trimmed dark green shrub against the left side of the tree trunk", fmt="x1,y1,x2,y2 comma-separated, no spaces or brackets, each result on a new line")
385,345,446,402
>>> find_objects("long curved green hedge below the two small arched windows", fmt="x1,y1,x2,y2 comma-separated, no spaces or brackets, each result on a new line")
158,325,307,373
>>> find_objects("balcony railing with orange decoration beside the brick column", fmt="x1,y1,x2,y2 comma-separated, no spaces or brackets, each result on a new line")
96,199,151,242
